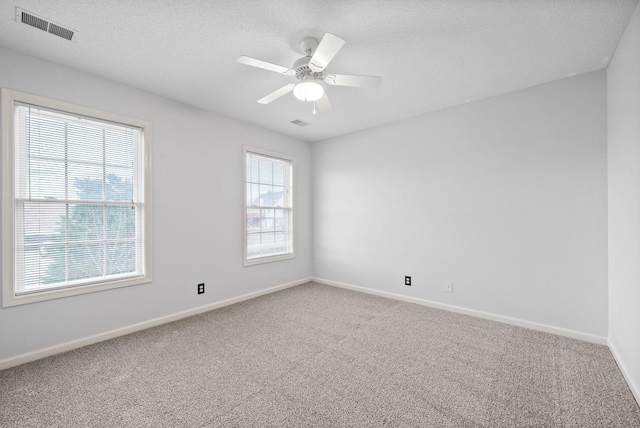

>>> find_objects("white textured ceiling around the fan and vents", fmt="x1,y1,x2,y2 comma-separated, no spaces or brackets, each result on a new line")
0,0,638,141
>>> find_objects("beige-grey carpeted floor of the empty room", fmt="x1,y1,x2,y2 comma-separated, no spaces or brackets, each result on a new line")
0,283,640,428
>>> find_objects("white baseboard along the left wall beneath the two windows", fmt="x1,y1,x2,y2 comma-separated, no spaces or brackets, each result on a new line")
0,278,311,370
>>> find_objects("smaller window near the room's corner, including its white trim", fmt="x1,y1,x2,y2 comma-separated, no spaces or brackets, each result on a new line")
244,147,295,266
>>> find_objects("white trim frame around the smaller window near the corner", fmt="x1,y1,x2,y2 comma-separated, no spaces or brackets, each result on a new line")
242,146,297,267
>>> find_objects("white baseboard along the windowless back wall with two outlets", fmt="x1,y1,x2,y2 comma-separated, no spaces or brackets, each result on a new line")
312,277,608,345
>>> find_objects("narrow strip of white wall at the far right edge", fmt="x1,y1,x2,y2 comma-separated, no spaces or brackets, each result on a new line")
607,0,640,401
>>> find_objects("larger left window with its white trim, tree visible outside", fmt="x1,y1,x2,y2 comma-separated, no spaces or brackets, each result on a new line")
2,89,151,307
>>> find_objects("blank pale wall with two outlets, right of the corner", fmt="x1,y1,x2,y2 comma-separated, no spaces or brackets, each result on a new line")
312,71,608,337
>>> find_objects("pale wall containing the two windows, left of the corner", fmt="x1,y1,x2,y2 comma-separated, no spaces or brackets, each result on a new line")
0,48,312,360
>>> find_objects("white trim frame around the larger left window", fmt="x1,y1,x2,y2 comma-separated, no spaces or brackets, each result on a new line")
0,88,153,308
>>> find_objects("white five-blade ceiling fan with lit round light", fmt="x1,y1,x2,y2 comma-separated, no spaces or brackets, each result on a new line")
236,33,382,114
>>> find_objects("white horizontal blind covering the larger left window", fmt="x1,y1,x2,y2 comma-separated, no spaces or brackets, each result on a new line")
13,102,145,296
